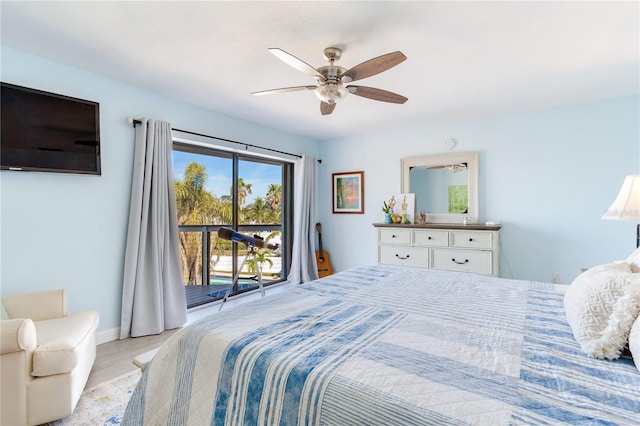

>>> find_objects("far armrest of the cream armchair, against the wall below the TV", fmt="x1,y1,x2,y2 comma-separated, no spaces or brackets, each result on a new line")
2,290,67,321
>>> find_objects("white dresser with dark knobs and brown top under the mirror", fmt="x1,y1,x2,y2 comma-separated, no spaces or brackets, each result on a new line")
373,223,500,276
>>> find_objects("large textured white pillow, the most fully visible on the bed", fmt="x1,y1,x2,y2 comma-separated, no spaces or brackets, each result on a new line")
564,262,640,359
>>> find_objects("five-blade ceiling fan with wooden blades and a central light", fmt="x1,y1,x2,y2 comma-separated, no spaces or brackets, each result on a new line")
252,47,407,115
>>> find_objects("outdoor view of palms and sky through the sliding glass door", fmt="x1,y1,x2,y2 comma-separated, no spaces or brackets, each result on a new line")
173,144,291,307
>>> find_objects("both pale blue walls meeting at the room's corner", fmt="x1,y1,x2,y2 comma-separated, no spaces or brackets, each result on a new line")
0,47,640,338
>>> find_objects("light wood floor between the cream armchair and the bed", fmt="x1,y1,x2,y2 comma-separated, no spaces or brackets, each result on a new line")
85,328,180,388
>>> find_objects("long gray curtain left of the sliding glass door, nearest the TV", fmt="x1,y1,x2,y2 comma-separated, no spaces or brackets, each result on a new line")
120,119,187,339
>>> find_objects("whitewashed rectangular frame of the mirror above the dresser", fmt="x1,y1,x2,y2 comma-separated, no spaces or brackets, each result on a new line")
400,152,478,223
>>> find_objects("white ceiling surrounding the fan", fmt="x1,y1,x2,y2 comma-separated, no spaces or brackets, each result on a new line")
1,0,640,139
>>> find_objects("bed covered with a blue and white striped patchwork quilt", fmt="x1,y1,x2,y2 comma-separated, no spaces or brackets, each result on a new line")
123,265,640,426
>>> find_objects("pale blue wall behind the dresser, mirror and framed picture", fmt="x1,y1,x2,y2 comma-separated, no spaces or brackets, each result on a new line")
318,96,640,283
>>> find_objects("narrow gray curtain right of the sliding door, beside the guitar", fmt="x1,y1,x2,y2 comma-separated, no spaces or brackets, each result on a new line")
287,155,318,284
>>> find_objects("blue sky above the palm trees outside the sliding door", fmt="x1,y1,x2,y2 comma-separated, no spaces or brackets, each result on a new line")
173,150,282,205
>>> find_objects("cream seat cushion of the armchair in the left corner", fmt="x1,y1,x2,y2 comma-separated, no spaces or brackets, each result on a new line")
31,311,99,377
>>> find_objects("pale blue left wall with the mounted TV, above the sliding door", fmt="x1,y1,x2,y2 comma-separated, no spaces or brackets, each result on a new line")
0,46,318,330
